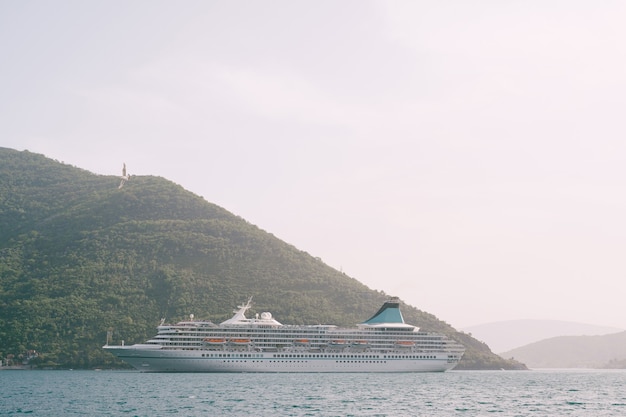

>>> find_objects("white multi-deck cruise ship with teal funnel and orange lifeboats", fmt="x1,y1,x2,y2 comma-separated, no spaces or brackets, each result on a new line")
103,298,465,372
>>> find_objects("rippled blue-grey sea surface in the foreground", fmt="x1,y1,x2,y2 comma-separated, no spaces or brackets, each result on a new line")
0,370,626,417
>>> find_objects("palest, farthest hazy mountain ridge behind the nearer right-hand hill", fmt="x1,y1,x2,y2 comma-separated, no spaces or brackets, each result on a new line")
461,319,624,353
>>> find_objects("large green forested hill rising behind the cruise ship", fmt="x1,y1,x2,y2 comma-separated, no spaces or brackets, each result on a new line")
0,148,523,369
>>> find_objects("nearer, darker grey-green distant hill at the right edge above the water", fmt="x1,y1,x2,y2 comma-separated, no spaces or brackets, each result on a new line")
501,331,626,369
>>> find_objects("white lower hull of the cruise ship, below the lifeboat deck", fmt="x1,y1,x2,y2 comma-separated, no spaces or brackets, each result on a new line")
105,346,458,372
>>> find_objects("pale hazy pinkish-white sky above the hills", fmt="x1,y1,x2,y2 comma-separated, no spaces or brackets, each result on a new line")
0,0,626,329
